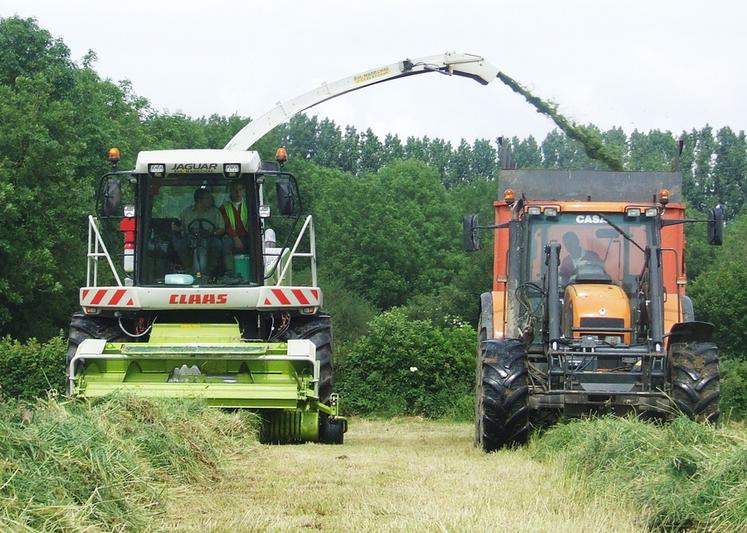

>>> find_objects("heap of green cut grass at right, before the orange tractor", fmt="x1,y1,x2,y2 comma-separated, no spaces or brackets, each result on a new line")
529,417,747,531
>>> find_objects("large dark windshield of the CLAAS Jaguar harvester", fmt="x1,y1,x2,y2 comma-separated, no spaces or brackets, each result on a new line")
140,175,256,286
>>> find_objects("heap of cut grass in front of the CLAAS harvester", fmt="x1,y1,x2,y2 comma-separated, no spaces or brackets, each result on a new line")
0,397,256,531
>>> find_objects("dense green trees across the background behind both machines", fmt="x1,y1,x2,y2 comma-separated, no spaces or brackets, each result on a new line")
0,17,747,362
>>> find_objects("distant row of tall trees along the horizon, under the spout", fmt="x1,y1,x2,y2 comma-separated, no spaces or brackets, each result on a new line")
277,115,747,217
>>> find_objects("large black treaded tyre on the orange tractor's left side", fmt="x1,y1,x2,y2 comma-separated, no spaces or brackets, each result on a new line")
475,339,530,452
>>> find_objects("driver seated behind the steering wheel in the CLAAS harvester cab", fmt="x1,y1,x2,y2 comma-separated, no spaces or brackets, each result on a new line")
173,187,226,274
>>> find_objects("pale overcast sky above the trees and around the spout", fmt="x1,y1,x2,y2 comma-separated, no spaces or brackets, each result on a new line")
0,0,747,143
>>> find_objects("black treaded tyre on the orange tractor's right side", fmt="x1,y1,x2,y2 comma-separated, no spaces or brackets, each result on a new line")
669,342,721,423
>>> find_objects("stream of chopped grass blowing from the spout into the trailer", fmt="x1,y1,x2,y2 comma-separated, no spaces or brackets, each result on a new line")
498,72,623,170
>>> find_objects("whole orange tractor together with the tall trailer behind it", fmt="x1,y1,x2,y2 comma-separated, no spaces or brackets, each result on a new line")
464,170,723,450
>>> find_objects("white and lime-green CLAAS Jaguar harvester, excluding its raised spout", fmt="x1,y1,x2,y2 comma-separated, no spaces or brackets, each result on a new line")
68,149,347,443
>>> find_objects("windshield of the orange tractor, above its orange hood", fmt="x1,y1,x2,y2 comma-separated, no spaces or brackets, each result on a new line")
527,213,653,294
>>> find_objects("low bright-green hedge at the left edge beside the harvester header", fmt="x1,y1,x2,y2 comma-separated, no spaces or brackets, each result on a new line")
0,337,67,400
